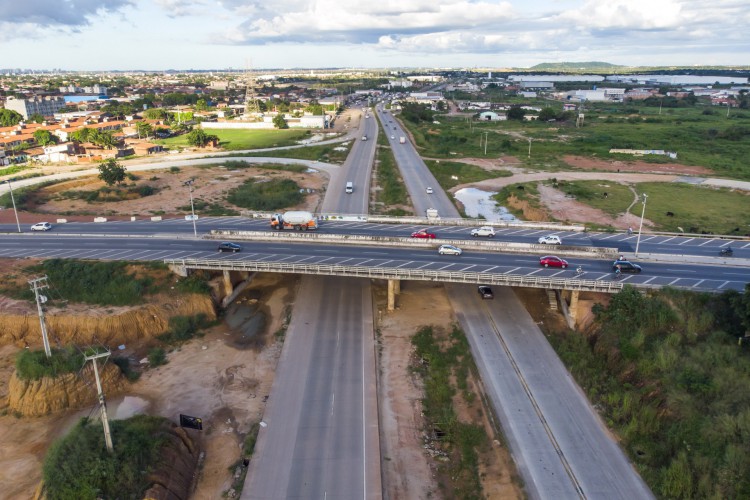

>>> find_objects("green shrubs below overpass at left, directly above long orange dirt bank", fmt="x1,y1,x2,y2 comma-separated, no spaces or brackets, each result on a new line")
41,259,155,306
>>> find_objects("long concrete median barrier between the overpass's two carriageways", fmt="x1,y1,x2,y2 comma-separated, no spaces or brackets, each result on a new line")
207,229,619,260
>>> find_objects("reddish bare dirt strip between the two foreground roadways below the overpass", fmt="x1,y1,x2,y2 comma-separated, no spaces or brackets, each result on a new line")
377,282,523,500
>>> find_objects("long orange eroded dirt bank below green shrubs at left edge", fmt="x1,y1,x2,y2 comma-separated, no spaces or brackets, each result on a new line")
0,294,216,348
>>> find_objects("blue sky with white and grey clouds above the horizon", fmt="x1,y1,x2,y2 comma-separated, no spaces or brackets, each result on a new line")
0,0,750,71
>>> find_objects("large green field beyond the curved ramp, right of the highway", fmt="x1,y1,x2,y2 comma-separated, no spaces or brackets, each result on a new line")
405,102,750,179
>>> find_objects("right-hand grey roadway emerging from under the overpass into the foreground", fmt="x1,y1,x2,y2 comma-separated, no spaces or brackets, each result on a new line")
447,285,654,500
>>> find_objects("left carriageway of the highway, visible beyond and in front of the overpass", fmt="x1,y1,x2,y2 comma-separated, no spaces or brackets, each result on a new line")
241,107,382,500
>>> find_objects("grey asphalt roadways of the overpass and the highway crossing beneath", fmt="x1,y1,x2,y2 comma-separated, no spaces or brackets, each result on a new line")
0,102,750,498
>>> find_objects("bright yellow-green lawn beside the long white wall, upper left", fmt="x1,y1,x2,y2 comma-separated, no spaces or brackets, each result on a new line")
154,129,310,151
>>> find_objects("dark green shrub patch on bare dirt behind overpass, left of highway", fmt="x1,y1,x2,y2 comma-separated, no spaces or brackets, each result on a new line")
227,179,305,210
